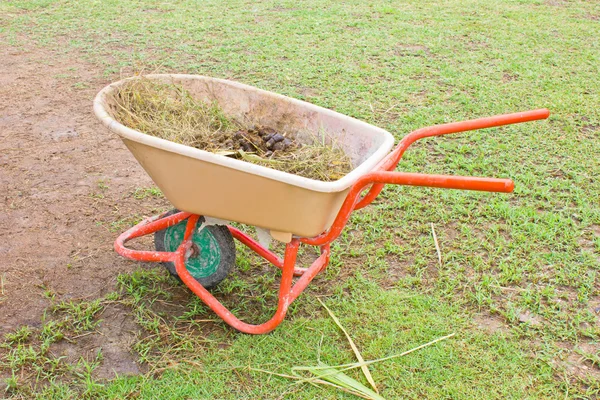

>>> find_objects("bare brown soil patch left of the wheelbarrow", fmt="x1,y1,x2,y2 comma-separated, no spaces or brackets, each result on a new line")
0,43,164,377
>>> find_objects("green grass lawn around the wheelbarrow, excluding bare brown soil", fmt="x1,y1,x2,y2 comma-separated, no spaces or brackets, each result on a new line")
0,0,600,398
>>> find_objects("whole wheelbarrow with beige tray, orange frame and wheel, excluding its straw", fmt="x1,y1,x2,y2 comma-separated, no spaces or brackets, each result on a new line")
94,74,549,334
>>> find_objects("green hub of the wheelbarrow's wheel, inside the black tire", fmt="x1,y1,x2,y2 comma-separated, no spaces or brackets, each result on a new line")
164,220,221,280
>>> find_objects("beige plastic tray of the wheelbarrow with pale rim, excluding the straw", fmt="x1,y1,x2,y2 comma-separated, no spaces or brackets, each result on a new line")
94,74,394,241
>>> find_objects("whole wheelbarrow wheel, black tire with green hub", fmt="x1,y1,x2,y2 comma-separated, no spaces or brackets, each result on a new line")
154,210,235,289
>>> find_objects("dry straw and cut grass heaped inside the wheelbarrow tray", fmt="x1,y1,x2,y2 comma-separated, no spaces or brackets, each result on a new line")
114,77,352,181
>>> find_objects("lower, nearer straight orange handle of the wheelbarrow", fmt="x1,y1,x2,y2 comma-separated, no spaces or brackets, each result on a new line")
364,171,515,193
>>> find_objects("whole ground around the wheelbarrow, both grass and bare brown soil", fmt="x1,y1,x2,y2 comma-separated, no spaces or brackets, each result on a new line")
0,0,600,399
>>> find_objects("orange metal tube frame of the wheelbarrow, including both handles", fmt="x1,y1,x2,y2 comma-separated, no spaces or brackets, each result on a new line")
115,109,550,334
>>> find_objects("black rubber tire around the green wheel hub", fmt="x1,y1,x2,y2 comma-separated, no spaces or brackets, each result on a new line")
154,210,235,289
